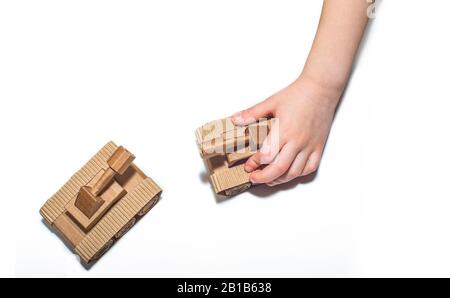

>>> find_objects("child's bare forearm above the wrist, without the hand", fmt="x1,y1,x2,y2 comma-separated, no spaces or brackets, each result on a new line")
302,0,369,95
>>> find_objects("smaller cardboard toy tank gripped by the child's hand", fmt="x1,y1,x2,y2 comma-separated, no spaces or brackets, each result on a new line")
195,118,273,197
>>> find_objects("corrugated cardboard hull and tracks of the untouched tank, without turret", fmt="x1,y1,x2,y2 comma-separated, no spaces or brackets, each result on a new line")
40,142,162,266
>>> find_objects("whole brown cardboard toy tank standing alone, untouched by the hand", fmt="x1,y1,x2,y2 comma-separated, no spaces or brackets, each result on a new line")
40,142,161,266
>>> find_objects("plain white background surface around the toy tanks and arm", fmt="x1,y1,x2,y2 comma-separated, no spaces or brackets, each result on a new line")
0,0,450,277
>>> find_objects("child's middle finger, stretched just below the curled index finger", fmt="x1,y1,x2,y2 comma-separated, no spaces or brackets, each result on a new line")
250,142,298,184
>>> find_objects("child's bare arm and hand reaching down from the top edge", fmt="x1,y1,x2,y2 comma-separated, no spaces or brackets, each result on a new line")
233,0,369,186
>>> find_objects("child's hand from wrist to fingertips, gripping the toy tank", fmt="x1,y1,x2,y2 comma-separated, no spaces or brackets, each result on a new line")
232,77,341,186
